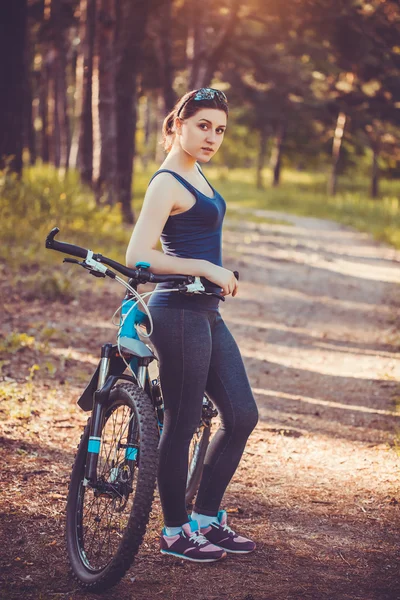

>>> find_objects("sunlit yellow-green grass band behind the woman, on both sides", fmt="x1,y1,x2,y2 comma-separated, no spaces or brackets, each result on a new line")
0,165,400,276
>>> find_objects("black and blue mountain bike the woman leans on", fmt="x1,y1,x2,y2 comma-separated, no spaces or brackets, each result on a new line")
46,227,234,592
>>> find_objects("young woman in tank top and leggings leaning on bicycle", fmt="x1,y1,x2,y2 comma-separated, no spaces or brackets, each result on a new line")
126,88,258,562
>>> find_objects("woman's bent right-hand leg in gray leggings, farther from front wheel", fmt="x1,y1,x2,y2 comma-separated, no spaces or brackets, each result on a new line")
194,314,258,516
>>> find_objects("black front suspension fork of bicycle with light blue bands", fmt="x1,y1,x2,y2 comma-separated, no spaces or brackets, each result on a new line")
83,344,148,487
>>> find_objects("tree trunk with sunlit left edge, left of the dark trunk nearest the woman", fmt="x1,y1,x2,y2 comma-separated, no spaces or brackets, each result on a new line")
93,0,118,204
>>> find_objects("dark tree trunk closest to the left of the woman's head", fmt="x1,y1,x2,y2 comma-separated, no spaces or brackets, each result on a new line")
116,0,154,224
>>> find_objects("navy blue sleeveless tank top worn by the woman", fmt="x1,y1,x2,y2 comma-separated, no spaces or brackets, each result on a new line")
149,168,226,311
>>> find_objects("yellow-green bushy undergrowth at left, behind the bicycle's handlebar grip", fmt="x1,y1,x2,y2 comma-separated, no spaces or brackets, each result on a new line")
0,165,130,268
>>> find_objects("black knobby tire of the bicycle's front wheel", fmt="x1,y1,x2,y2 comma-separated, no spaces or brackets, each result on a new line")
66,383,158,592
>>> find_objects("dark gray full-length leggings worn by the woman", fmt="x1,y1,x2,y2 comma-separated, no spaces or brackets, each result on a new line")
150,307,258,527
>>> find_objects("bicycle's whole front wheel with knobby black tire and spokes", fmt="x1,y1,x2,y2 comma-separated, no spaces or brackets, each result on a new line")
66,383,158,591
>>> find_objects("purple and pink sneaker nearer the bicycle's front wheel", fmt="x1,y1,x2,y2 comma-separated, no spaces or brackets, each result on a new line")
161,521,226,562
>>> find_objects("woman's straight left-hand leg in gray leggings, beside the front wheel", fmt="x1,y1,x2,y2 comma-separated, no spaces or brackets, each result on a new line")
151,307,211,527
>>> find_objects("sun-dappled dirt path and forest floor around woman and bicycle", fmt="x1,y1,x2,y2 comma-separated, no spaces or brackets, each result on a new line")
0,211,400,600
